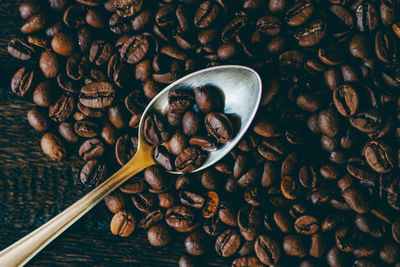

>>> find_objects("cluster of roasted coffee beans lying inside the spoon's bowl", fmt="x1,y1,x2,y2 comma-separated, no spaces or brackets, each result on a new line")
143,85,233,173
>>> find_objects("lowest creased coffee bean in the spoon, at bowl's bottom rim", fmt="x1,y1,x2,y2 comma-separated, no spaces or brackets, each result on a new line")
175,147,205,172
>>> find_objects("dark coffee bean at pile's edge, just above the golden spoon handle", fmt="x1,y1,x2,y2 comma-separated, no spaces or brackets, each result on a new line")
80,159,107,187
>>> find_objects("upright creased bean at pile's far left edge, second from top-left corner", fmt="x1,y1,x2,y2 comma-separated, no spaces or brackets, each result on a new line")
11,67,36,97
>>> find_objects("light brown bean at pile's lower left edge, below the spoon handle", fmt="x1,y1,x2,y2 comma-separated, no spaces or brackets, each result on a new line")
110,210,136,237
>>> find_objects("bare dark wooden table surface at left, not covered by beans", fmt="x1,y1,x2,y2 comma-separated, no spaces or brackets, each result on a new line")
0,0,232,266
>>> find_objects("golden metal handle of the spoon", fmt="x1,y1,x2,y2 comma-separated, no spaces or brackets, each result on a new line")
0,147,154,267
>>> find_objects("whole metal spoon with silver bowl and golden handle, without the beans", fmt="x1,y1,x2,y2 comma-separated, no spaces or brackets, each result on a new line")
0,65,261,267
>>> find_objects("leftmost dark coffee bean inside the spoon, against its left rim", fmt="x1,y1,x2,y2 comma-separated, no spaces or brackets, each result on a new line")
144,114,170,145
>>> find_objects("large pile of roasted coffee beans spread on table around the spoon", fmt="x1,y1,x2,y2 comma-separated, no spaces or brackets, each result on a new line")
8,0,400,267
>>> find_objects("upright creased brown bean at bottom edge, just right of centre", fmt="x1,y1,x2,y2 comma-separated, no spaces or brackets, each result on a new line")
254,235,281,265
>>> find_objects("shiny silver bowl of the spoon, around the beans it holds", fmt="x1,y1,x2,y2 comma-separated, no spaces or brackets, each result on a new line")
138,65,262,174
